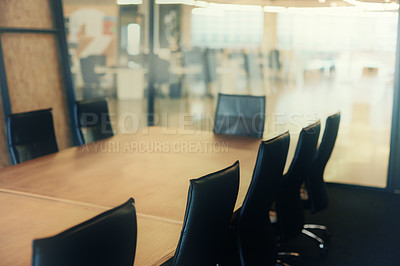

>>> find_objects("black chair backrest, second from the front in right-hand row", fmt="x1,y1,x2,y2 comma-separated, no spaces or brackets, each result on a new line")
237,133,290,265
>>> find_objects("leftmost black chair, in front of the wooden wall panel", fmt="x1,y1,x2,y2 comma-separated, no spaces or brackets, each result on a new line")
7,109,58,164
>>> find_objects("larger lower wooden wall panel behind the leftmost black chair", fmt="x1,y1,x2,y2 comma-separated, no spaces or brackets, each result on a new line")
1,33,73,152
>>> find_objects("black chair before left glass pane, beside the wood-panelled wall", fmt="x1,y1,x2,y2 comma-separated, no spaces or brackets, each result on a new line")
75,99,114,144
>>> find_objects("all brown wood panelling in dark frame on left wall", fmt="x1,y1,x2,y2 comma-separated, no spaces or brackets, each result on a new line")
0,0,73,167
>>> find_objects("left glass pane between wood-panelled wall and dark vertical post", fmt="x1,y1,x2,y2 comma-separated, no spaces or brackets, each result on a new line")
63,0,148,134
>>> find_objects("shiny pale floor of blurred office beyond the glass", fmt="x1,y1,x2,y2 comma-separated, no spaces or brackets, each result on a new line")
110,65,393,187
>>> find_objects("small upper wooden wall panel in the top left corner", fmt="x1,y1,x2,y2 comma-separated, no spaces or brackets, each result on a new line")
0,0,53,28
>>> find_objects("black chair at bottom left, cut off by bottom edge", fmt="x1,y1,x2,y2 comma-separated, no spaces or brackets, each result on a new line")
32,198,137,266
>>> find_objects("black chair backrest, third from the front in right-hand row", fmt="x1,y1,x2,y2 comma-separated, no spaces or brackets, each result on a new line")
276,121,321,241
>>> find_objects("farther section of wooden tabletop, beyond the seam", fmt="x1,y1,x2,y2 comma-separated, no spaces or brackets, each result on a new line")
0,128,268,222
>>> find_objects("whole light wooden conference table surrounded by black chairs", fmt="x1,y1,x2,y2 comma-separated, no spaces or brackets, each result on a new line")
0,127,294,265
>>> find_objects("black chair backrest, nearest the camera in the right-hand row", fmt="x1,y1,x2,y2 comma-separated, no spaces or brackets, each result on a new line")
173,162,239,265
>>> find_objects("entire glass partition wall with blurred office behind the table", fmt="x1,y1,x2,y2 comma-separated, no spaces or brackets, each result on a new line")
64,0,398,187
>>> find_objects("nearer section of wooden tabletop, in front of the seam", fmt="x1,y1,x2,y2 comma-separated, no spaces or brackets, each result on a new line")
0,190,182,266
